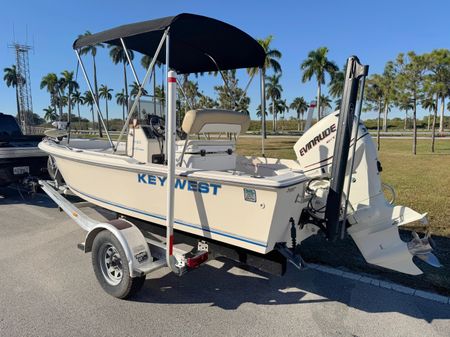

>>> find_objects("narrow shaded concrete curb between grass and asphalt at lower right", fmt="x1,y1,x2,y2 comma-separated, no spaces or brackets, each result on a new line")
307,263,450,304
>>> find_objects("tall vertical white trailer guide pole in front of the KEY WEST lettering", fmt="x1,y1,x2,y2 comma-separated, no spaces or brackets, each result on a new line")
166,67,179,273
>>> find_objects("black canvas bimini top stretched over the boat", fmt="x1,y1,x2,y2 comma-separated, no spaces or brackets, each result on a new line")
73,13,265,74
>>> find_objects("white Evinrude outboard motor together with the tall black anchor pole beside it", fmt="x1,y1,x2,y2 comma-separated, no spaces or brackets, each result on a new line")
294,56,440,275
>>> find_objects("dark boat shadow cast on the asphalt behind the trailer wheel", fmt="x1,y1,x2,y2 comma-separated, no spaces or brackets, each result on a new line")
131,259,450,322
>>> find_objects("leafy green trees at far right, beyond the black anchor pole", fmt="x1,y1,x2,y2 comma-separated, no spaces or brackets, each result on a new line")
365,49,450,154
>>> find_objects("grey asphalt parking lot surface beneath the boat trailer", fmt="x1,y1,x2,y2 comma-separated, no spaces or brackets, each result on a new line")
0,189,450,337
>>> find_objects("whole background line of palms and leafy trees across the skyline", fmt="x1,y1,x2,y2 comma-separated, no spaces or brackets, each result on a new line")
4,31,450,154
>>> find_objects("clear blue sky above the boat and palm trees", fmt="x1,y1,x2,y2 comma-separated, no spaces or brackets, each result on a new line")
0,0,450,121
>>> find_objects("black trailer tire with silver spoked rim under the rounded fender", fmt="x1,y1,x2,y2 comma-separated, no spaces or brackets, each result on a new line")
92,230,145,298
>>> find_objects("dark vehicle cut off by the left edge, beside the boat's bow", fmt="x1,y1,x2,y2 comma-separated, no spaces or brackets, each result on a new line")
0,113,48,186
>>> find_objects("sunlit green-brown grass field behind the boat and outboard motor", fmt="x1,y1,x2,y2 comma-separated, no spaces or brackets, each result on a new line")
238,137,450,237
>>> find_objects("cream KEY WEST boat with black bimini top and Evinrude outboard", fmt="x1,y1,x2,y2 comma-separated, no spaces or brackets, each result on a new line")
39,14,439,286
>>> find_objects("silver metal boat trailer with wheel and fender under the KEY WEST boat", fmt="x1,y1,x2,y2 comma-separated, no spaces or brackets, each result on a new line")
39,180,298,298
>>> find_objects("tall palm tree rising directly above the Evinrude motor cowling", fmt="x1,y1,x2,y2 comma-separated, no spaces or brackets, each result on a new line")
300,47,339,120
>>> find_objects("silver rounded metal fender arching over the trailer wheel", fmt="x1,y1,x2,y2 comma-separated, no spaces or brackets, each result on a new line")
84,219,153,277
